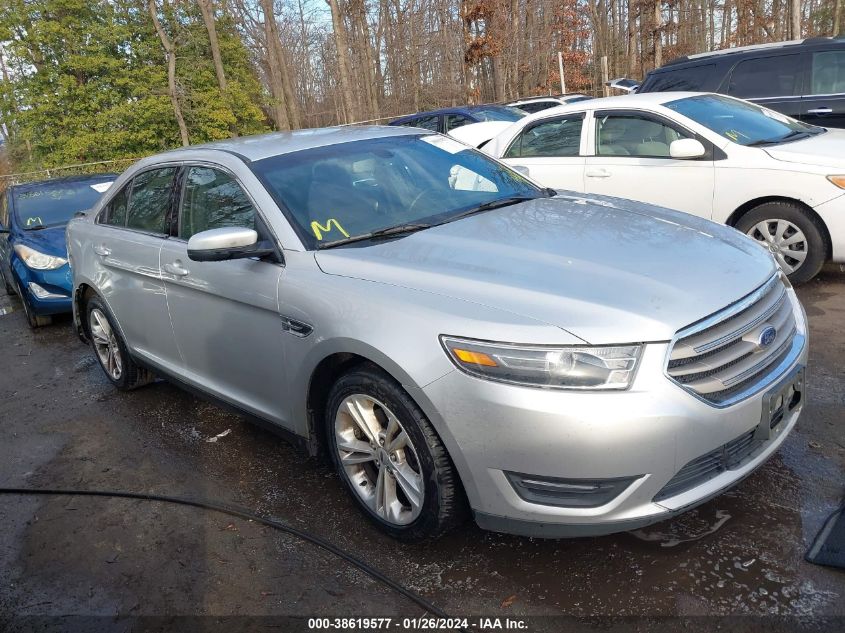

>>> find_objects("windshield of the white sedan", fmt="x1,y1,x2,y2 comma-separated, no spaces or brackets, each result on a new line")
664,95,824,145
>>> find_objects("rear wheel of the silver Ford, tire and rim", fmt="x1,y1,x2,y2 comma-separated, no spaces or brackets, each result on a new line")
85,297,154,391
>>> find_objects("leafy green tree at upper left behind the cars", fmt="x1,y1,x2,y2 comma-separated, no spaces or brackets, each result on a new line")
0,0,267,170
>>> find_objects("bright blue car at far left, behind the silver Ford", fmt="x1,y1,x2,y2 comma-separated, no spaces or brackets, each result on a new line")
0,174,116,328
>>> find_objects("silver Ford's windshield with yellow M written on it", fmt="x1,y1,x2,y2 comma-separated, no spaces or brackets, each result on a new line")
251,134,545,249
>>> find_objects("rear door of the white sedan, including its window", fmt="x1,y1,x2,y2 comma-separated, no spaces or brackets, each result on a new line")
502,112,585,192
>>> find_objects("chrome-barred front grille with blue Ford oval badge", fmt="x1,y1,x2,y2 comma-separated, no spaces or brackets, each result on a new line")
666,276,797,405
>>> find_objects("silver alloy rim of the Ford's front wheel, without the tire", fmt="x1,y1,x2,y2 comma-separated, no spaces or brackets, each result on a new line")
334,394,425,525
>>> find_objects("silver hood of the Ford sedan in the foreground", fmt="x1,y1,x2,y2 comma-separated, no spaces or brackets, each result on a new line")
315,195,775,344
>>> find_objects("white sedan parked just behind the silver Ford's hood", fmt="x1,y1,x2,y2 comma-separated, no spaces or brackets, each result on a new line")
482,92,845,283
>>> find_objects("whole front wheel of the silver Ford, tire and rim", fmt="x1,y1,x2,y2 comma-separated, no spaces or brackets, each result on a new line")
324,364,467,541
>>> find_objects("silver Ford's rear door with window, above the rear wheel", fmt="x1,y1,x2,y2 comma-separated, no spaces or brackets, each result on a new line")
84,166,180,369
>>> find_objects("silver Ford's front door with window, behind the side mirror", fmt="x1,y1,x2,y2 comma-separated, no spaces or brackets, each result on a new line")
161,164,289,424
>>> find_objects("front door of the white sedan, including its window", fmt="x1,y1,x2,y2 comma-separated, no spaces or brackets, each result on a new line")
584,110,714,219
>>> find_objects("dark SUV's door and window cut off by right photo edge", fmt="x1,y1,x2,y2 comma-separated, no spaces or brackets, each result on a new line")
800,48,845,128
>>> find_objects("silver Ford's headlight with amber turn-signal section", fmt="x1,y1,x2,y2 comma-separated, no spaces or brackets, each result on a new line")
440,336,642,389
